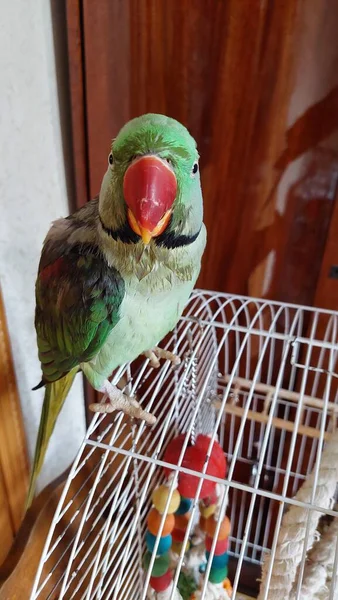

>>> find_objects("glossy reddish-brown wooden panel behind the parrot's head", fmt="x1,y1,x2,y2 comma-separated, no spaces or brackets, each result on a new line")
68,0,338,304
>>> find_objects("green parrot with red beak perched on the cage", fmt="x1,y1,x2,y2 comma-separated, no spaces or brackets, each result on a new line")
27,114,206,506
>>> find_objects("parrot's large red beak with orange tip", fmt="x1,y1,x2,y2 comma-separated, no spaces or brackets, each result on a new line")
123,154,177,244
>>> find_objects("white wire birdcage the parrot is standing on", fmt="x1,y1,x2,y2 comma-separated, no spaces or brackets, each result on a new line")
31,290,338,600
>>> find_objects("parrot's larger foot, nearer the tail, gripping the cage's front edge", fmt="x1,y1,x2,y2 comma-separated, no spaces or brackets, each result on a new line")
89,379,156,425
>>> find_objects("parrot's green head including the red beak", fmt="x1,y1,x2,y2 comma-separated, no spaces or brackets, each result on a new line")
99,114,203,248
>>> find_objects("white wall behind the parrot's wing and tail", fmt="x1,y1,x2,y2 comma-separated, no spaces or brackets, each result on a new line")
0,0,85,488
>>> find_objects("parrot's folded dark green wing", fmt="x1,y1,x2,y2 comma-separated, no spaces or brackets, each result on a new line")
35,245,125,382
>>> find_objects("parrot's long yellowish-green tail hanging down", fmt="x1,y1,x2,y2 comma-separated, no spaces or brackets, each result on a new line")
26,367,78,510
